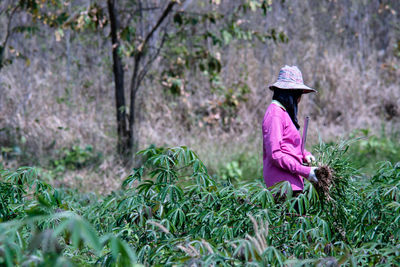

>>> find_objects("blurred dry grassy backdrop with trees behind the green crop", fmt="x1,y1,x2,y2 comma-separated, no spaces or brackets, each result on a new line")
0,0,400,192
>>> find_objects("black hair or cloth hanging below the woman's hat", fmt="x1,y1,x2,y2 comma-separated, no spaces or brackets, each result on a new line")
272,88,302,130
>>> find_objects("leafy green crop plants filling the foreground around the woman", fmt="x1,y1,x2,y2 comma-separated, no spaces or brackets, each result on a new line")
0,141,400,266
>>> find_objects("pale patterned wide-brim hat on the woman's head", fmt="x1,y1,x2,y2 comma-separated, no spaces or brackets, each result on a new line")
269,65,317,94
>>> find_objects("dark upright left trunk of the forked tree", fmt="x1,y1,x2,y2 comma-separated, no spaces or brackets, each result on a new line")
107,0,130,154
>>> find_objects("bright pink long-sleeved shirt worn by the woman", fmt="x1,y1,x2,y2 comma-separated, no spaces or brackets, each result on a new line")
262,103,311,191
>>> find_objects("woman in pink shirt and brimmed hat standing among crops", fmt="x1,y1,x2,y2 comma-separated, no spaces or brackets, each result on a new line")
262,66,318,192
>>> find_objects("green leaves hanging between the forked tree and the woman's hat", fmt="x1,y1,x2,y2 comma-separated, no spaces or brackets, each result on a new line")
161,0,287,101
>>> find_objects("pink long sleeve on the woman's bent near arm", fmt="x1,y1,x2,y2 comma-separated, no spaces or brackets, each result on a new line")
263,116,311,177
